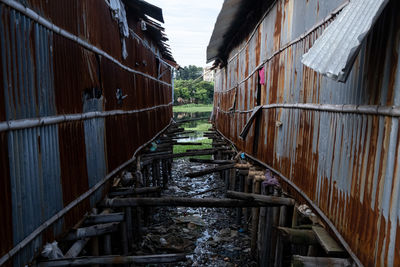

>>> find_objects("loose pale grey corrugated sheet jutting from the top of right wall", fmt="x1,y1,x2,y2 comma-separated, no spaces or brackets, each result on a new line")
302,0,389,82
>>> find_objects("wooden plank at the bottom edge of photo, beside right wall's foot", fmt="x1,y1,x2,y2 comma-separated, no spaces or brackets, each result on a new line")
291,255,355,267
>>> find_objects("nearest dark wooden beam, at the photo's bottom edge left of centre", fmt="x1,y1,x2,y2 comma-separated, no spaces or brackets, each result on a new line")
38,254,186,267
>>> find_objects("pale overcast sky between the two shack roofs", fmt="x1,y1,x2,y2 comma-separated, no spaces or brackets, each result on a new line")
146,0,223,67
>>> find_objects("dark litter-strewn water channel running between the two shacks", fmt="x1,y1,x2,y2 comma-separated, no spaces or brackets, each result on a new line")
137,113,257,266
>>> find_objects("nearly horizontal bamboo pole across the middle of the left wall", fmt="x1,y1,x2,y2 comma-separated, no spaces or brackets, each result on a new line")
0,102,173,132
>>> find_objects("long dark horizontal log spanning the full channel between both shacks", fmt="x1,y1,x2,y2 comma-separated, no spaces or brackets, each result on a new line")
102,197,287,208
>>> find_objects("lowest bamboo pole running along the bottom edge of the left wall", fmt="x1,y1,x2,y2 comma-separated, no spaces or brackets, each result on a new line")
0,119,172,266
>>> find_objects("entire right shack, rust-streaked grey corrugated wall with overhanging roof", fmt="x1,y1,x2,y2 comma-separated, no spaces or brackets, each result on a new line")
207,0,400,266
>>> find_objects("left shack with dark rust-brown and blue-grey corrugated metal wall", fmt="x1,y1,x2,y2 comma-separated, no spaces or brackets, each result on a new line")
0,0,175,266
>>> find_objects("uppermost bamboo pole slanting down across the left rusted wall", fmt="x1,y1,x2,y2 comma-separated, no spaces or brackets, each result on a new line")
0,0,171,86
